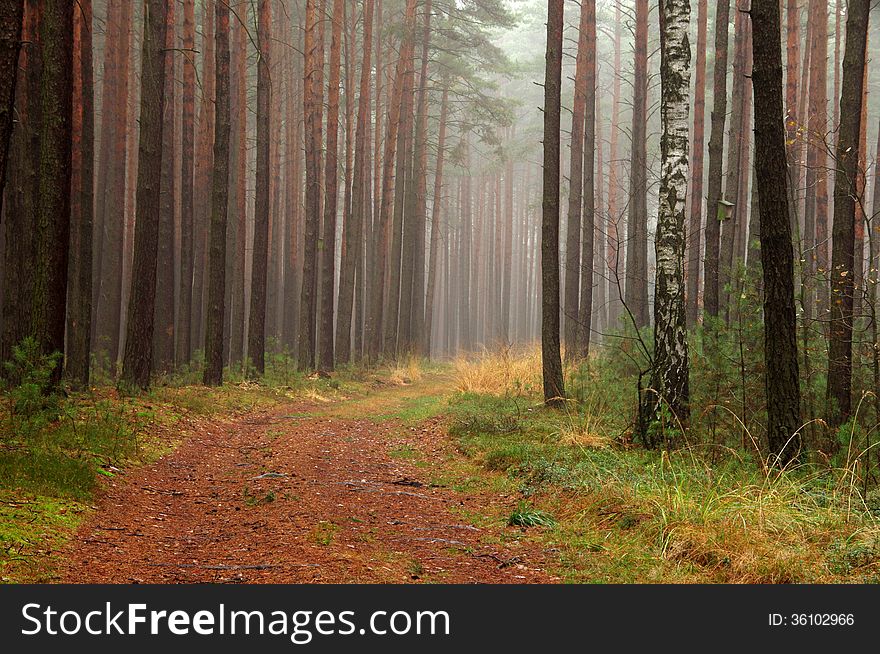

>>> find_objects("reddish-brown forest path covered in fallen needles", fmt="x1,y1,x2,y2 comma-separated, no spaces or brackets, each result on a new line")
61,373,555,583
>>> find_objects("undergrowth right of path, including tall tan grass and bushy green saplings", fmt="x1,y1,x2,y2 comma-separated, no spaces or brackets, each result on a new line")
448,348,880,583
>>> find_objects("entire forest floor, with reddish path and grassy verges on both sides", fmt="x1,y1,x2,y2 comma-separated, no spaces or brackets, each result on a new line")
0,349,880,583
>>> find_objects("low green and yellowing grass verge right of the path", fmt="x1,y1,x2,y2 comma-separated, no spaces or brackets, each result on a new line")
444,393,880,583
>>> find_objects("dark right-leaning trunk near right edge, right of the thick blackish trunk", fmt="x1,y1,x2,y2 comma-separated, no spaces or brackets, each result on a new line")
827,0,870,428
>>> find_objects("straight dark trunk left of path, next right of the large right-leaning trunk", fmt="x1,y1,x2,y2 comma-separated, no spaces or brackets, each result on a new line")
202,2,230,386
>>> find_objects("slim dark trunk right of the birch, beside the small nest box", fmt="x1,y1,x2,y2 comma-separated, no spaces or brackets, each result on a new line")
703,0,730,317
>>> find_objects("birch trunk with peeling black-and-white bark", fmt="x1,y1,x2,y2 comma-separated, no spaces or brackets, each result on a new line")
637,0,691,448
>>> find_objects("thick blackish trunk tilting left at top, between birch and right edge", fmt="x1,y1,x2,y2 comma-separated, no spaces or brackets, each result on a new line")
751,0,800,464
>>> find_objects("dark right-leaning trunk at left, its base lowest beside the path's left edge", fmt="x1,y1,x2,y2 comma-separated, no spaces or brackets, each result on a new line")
122,0,173,389
